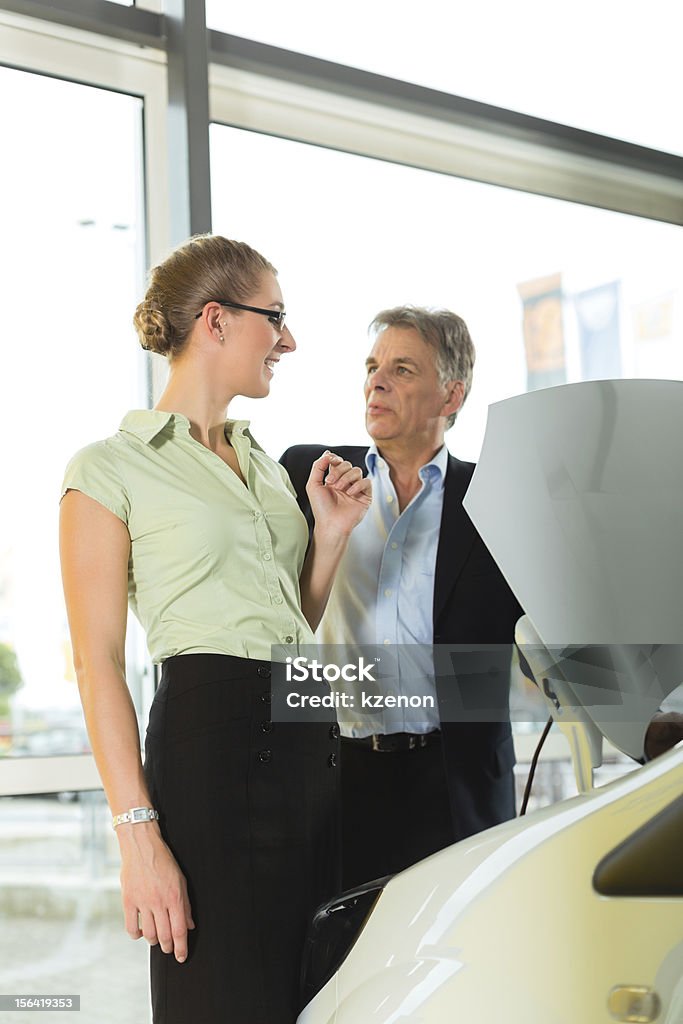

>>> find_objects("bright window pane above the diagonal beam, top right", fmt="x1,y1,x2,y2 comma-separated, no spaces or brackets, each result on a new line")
207,0,683,154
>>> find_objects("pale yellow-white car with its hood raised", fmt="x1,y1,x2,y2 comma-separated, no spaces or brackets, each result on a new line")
299,381,683,1024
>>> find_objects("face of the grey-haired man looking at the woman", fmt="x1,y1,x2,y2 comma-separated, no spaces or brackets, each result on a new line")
365,327,462,443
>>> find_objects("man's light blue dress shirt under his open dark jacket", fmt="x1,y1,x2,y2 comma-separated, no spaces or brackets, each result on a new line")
316,445,449,737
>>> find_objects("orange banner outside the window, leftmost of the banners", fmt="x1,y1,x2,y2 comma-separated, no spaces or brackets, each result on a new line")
517,273,566,391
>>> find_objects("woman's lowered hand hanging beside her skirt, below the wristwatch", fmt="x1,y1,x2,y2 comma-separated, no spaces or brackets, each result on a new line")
117,822,195,964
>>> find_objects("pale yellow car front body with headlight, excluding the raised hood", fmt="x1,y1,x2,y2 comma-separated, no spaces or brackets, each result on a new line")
299,744,683,1024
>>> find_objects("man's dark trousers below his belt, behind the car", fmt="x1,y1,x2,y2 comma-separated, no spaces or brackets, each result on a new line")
341,735,456,889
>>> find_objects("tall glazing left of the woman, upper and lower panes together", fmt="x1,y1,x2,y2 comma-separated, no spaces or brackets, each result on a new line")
0,61,151,1024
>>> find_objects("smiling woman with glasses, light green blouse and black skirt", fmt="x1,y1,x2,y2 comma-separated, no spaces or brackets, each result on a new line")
60,236,371,1024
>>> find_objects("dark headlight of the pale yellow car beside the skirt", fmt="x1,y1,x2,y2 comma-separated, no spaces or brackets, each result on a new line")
301,874,391,1007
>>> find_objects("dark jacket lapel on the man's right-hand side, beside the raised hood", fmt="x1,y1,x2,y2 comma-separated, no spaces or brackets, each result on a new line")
433,455,477,629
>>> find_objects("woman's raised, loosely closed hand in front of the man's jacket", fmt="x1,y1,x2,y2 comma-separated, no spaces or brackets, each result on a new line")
306,452,373,536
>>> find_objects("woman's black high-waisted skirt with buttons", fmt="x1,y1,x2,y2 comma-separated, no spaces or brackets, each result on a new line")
144,654,339,1024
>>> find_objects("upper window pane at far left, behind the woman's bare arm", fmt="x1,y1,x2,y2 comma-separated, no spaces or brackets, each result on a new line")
0,69,146,755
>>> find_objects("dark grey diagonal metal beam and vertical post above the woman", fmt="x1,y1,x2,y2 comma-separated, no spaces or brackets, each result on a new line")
0,0,683,190
